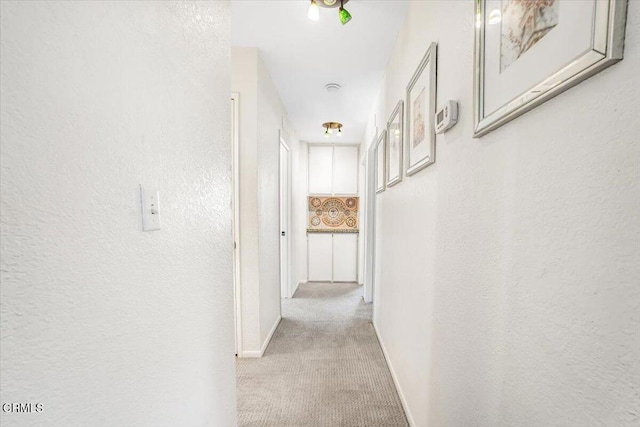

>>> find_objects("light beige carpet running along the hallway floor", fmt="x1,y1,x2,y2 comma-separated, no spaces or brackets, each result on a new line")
236,283,408,427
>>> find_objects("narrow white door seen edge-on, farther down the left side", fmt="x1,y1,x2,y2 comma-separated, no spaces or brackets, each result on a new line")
280,139,292,298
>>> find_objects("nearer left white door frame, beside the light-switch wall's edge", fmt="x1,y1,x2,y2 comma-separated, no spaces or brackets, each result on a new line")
231,92,242,356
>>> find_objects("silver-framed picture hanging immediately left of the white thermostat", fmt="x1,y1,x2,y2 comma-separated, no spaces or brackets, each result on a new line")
405,43,437,175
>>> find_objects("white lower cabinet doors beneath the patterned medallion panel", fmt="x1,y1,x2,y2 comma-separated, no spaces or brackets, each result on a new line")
307,233,358,282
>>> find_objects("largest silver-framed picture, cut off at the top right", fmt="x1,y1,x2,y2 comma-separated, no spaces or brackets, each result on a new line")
474,0,627,137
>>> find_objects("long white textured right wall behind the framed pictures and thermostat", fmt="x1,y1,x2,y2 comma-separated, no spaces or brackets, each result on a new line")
366,1,640,426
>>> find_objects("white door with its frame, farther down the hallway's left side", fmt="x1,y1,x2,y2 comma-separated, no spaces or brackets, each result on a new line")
278,135,293,298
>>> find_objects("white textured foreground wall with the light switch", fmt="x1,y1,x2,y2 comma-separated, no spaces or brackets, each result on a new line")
0,1,236,427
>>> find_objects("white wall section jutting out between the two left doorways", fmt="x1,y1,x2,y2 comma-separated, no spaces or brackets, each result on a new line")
231,46,299,356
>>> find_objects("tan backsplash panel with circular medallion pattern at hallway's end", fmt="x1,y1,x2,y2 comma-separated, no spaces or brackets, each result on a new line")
307,196,360,233
